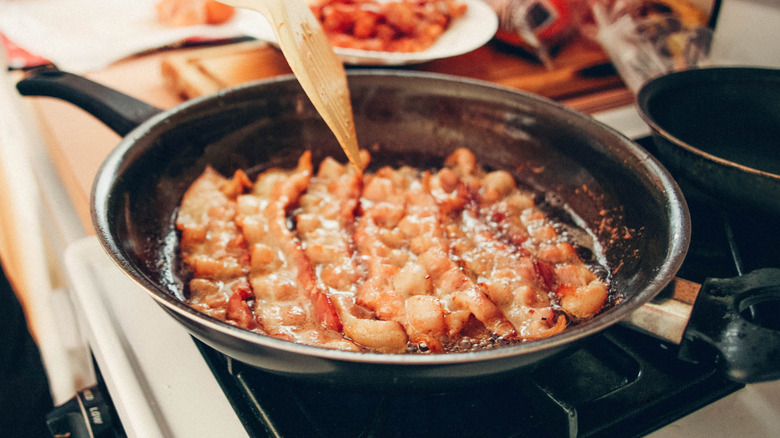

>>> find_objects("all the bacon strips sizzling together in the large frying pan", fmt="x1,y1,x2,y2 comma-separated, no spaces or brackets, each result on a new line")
177,149,608,353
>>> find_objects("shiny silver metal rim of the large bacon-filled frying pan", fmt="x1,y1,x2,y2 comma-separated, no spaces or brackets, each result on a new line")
91,69,690,366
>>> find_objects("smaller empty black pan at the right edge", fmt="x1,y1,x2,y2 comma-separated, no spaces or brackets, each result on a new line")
637,67,780,216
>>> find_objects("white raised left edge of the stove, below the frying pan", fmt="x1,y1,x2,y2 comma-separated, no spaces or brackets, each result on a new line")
65,237,247,437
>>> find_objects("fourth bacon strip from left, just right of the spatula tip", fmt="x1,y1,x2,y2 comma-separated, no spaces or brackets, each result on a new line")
355,163,515,350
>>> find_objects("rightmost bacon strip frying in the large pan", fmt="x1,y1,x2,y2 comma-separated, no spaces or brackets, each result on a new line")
437,149,607,340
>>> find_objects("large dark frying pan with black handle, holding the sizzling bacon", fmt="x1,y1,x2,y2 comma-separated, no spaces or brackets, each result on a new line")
17,71,780,390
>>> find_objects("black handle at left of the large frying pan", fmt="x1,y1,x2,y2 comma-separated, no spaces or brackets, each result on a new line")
16,69,162,137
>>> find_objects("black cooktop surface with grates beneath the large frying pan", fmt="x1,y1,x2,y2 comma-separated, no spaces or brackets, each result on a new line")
198,135,780,438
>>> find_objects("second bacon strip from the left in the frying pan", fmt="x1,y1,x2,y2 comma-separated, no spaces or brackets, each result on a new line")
236,153,354,349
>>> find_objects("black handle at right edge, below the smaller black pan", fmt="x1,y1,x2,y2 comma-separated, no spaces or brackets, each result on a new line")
680,268,780,383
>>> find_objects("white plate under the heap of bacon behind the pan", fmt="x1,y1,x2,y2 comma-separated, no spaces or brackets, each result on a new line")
235,0,498,65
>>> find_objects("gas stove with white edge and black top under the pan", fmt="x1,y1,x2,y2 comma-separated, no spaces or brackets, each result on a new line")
58,108,780,437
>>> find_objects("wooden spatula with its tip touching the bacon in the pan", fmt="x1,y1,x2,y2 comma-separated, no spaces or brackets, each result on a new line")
219,0,362,172
